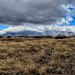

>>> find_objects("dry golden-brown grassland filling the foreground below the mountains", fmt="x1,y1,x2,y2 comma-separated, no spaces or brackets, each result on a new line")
0,37,75,75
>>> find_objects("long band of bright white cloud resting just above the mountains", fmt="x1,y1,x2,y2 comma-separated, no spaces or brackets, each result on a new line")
0,25,75,34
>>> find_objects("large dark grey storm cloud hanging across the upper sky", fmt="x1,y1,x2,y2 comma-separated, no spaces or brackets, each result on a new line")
0,0,73,25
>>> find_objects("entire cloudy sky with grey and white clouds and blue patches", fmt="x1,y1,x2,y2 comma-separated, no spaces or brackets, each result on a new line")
0,0,75,34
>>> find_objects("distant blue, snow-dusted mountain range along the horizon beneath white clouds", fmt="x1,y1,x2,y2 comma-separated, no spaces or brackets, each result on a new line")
2,30,75,36
